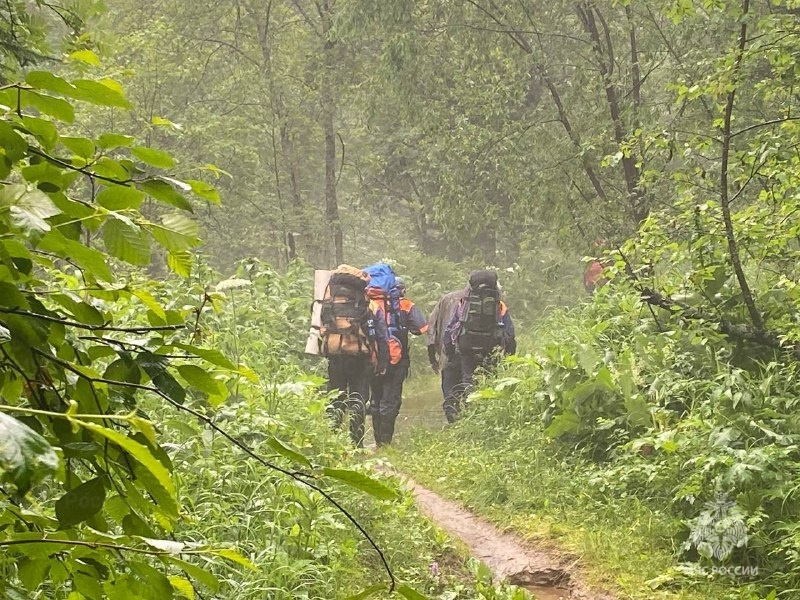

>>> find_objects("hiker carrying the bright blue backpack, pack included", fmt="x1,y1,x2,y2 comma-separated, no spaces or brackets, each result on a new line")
365,263,428,446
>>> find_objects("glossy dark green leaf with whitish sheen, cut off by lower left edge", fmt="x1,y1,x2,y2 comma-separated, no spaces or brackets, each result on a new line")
0,413,58,496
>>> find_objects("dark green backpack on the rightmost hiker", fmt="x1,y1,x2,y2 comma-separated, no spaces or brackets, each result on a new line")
457,271,502,354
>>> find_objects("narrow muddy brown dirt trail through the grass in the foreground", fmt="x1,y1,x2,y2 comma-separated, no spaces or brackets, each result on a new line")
379,467,614,600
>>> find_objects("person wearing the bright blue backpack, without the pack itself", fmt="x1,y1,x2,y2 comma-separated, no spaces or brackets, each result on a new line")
370,277,428,446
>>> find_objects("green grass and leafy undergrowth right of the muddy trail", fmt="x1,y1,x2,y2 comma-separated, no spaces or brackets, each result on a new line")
391,281,800,600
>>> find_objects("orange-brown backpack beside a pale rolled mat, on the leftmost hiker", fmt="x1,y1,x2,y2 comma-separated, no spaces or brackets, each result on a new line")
319,265,372,356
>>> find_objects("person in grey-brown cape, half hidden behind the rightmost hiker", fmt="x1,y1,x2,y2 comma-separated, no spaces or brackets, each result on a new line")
427,290,464,423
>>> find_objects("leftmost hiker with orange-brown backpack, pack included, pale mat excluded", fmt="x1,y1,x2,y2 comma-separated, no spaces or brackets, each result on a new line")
319,265,389,447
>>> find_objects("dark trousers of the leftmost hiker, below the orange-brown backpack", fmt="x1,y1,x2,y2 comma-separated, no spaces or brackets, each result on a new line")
328,356,372,448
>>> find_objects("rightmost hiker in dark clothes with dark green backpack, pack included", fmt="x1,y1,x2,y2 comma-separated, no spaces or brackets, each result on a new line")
444,271,517,414
